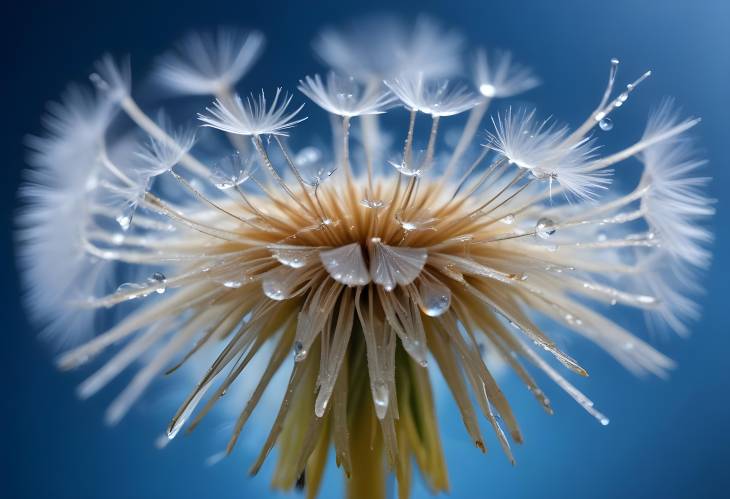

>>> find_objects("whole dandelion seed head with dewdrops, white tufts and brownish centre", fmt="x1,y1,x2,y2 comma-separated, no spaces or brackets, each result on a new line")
18,15,713,498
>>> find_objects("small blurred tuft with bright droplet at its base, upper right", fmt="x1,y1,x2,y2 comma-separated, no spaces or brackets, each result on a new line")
474,50,540,98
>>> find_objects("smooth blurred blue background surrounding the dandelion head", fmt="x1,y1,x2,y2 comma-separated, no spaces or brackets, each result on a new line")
0,0,730,499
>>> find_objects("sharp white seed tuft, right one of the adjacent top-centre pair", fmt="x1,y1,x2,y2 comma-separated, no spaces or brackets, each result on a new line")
385,72,478,116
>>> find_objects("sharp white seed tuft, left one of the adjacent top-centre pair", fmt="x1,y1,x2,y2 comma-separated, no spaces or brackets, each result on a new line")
299,72,394,117
